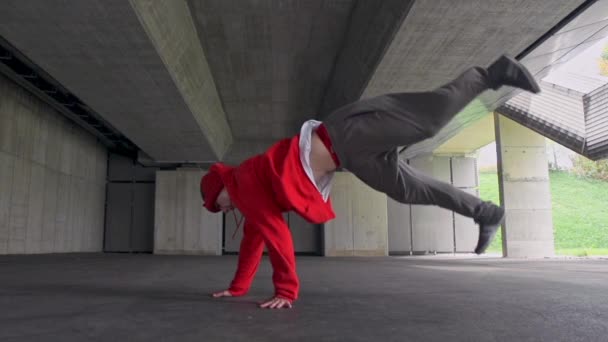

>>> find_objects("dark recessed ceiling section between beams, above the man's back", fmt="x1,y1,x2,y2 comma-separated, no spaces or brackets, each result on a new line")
188,0,356,160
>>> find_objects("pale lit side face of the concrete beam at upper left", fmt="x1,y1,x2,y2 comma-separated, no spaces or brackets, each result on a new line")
130,0,232,159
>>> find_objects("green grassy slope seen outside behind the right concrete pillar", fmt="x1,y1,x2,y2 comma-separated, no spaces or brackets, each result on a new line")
479,172,608,256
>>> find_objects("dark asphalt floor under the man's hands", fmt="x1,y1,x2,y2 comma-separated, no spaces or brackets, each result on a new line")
0,254,608,342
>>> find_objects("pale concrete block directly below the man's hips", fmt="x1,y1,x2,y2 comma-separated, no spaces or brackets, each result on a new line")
324,172,388,256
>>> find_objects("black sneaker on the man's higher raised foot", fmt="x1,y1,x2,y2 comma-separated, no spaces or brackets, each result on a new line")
487,55,540,94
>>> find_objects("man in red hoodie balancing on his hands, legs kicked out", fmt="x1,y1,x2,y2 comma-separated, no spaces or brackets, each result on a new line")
201,56,540,309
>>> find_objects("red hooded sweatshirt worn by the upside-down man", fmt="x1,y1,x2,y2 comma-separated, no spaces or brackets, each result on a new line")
210,135,336,301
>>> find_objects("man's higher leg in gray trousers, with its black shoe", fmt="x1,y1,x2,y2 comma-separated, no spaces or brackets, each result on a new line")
325,56,539,164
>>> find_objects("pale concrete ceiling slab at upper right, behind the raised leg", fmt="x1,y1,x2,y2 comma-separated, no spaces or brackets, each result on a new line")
361,0,584,158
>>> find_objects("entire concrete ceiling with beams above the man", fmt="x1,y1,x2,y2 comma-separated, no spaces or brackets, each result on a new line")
0,0,600,166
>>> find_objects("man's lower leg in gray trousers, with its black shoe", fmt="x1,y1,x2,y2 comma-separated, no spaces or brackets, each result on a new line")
349,149,504,253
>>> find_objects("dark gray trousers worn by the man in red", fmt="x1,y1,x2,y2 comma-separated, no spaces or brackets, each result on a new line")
324,67,493,223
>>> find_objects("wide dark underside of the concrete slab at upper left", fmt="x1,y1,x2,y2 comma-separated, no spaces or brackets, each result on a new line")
0,0,230,161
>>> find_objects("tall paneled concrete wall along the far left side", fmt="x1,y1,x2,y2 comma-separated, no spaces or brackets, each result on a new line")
0,75,107,254
